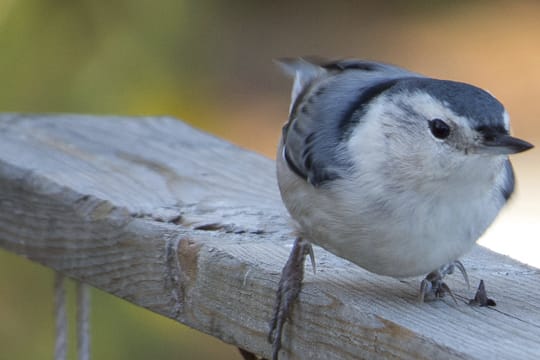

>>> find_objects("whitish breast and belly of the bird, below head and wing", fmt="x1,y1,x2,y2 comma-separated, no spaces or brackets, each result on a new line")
277,142,504,278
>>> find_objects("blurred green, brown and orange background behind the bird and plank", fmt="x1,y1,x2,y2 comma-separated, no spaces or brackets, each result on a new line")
0,0,540,360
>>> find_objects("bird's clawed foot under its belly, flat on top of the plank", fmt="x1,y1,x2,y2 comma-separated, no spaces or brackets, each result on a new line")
418,260,470,303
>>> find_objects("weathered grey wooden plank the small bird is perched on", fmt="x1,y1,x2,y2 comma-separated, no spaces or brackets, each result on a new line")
0,114,540,359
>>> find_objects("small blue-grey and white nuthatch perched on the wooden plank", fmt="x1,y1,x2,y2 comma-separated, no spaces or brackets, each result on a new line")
268,57,533,359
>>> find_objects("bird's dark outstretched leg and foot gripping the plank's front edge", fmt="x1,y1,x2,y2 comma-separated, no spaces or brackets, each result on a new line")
268,237,315,360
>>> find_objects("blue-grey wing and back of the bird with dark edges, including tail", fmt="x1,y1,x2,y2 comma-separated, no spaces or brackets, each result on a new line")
280,59,420,186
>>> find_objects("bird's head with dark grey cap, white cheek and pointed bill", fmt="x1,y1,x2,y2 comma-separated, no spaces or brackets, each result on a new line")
350,77,533,188
